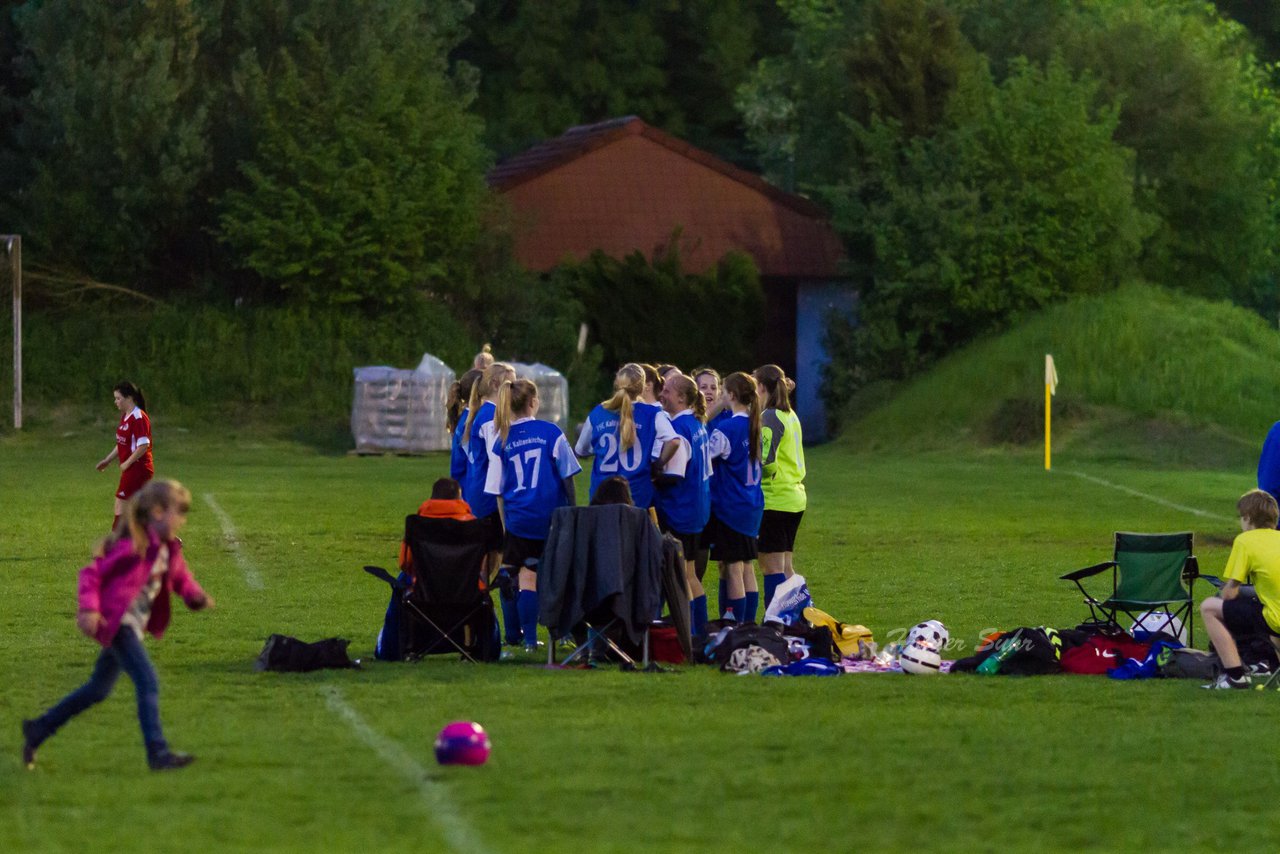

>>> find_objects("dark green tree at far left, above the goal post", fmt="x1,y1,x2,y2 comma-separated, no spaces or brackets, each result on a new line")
10,0,210,287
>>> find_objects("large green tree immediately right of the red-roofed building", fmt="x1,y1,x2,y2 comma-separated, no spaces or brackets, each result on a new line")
829,60,1153,391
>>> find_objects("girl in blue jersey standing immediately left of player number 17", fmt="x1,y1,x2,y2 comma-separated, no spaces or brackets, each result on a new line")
456,362,521,645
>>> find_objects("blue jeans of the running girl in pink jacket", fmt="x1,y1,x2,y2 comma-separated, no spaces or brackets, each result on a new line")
35,626,169,755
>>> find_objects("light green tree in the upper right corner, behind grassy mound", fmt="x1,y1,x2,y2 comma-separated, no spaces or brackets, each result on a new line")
1059,0,1280,309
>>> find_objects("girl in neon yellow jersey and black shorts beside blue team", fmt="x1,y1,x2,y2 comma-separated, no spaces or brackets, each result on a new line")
753,365,808,608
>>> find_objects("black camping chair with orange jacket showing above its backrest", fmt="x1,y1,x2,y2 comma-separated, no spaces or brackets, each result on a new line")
365,515,500,662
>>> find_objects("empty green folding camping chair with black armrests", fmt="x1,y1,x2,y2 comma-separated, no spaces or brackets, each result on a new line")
1060,531,1199,647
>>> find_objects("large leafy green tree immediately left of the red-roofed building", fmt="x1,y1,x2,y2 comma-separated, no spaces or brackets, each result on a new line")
219,0,488,305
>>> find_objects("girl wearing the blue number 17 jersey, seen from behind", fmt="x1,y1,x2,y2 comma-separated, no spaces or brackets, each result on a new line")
485,379,582,649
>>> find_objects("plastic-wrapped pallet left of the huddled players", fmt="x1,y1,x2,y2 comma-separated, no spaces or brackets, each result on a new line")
351,355,454,453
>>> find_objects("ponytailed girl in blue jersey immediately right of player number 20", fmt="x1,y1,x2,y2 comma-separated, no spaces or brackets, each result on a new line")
658,374,712,635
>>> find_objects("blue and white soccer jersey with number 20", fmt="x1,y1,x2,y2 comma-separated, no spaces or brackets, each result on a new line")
575,401,677,507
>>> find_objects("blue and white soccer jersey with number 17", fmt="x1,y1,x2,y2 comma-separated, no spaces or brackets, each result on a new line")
485,417,582,540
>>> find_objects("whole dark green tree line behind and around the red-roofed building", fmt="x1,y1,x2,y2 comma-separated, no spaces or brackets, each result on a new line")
0,0,1280,419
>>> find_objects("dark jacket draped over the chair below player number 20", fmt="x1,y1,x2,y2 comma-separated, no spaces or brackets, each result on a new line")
538,504,662,643
